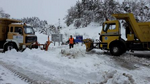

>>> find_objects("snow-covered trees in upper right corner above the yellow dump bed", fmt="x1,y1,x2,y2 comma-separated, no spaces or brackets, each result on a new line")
122,0,150,22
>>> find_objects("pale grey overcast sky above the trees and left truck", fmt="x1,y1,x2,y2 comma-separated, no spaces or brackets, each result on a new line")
0,0,122,24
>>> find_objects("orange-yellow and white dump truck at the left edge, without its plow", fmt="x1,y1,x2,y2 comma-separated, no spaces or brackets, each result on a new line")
0,18,37,52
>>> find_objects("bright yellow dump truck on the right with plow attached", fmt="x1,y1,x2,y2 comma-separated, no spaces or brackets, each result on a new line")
84,13,150,56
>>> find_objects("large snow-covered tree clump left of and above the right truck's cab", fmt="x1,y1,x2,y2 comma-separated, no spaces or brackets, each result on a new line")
66,0,120,27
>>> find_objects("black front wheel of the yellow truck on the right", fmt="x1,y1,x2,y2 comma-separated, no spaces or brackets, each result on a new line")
110,45,123,56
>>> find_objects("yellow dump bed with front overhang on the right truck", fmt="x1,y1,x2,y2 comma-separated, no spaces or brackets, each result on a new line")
113,13,150,43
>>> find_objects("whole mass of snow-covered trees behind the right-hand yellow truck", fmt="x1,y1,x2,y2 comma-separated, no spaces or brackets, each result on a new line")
66,0,150,27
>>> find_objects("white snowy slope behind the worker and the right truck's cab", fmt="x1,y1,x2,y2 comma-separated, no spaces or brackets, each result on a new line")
61,23,126,41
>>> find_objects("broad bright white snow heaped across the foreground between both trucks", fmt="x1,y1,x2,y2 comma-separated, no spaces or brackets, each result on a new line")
0,45,138,84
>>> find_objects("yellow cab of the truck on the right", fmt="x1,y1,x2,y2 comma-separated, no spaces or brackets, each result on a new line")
100,20,121,49
